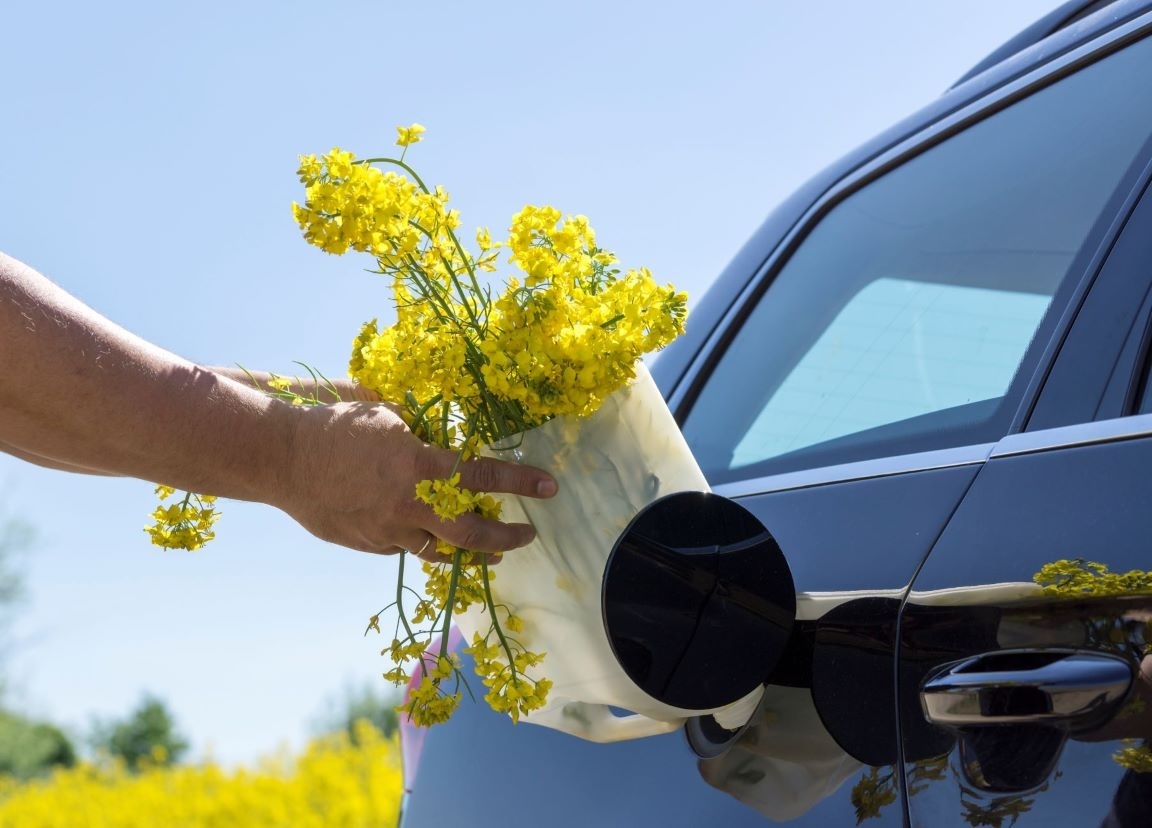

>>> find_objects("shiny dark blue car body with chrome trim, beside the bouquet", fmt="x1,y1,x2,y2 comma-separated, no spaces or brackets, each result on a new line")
402,0,1152,828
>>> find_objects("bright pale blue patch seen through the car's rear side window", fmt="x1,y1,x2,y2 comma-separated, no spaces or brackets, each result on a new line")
733,276,1048,468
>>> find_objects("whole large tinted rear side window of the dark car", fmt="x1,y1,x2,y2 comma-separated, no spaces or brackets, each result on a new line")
683,33,1152,483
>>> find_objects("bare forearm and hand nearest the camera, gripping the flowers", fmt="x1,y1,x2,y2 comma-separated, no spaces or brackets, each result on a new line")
0,253,555,552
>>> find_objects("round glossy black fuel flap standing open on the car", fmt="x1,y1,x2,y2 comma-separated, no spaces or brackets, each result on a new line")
602,492,796,711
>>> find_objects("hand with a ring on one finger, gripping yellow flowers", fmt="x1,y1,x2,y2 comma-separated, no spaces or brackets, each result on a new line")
270,402,556,561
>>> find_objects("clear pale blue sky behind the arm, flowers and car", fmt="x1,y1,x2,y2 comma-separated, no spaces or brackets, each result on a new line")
0,0,1058,762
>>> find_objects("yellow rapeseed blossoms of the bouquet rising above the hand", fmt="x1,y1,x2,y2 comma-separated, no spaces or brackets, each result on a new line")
294,135,687,439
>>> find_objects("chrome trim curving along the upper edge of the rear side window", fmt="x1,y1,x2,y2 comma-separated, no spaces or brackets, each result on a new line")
668,6,1152,421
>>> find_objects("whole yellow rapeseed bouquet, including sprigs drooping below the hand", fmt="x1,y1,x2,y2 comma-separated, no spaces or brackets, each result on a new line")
293,124,687,724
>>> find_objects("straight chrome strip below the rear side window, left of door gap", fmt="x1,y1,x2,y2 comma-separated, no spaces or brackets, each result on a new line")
712,446,990,497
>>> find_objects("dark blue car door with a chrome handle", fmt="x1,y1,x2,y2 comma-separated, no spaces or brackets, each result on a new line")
892,24,1152,828
